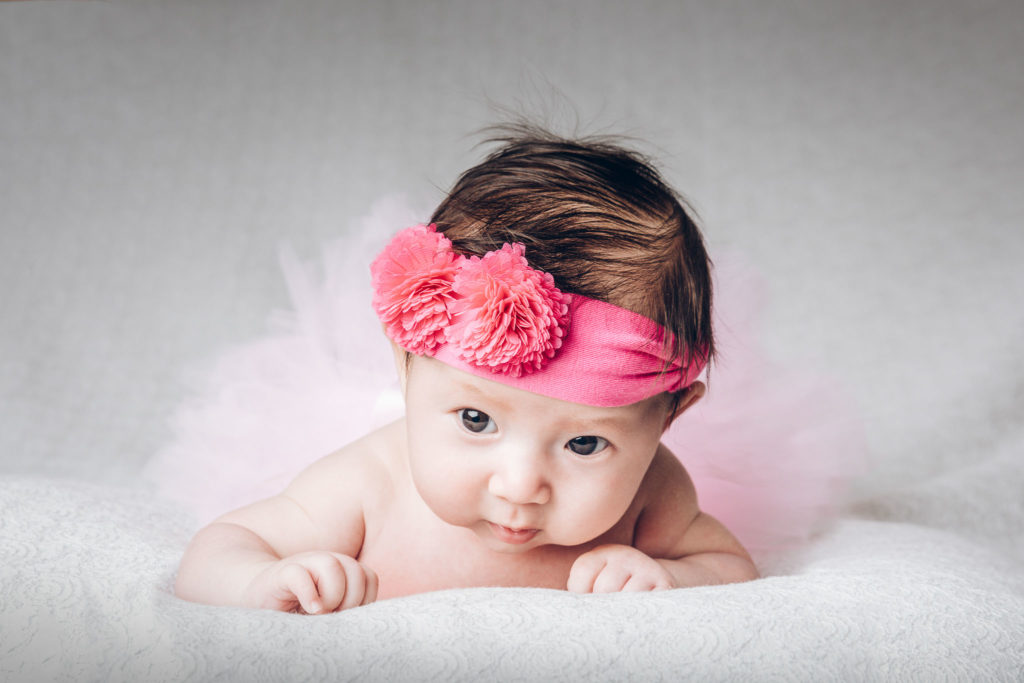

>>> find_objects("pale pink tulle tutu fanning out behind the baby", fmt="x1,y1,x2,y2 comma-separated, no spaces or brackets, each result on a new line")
145,201,863,557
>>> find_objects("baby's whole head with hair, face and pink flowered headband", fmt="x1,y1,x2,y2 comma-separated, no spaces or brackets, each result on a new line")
372,128,714,551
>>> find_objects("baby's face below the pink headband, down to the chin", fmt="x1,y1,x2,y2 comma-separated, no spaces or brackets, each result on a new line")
406,356,669,552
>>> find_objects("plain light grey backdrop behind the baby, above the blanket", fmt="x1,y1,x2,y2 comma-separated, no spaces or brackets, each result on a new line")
0,0,1024,492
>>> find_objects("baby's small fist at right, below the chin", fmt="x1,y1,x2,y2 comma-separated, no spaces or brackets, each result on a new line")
566,544,676,593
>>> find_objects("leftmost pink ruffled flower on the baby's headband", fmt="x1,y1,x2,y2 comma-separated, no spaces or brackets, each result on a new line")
370,225,459,354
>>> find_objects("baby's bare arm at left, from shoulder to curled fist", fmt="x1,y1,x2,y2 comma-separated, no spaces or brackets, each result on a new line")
174,454,377,613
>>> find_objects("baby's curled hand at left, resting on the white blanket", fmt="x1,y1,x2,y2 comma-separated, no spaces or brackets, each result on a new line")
244,551,377,614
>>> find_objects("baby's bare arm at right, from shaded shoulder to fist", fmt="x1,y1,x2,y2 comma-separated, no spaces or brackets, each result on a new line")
568,446,758,593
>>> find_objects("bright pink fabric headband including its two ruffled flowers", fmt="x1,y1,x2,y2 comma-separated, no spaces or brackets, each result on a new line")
370,225,705,407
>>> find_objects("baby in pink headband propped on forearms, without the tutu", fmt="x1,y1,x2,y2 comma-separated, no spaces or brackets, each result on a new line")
175,126,758,614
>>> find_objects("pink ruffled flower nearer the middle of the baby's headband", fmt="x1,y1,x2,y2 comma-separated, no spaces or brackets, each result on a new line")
445,244,570,377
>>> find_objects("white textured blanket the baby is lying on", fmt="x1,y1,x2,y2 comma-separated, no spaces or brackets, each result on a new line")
0,439,1024,681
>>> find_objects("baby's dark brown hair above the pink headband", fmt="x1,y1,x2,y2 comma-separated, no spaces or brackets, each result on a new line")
430,124,715,382
